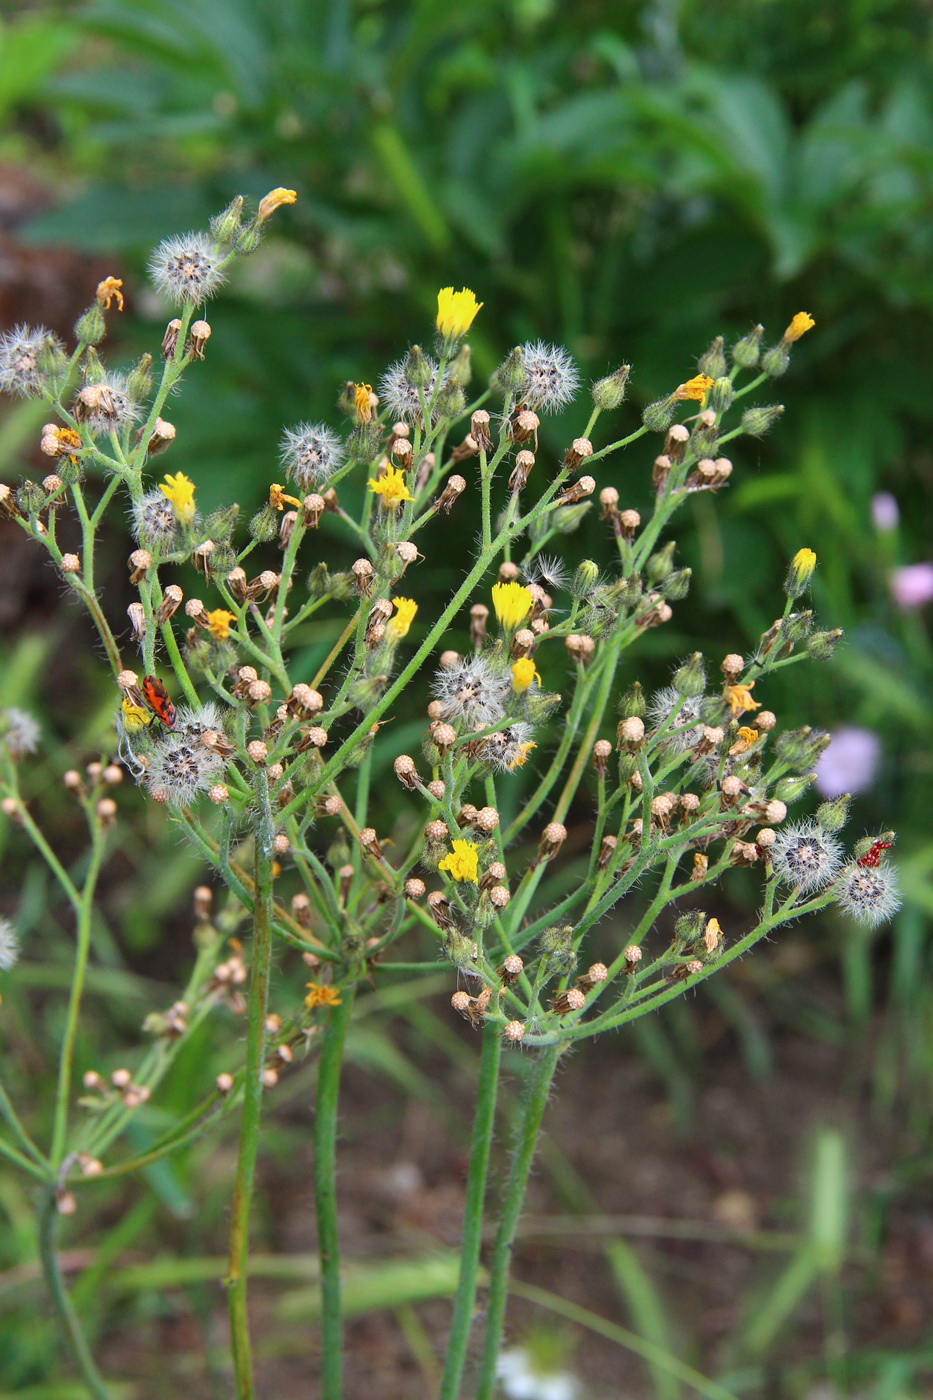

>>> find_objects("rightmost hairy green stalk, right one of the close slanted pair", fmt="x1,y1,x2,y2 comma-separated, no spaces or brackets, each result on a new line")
476,1044,560,1400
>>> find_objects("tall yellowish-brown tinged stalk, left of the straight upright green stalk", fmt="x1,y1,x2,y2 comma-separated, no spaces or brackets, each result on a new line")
227,770,273,1400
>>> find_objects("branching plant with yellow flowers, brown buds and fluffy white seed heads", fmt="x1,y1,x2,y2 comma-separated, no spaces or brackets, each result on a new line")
0,190,898,1400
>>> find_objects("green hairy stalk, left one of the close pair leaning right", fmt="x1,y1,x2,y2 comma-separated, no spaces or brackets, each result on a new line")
438,1025,502,1400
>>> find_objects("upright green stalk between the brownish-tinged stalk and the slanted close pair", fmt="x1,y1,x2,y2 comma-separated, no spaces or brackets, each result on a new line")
314,984,353,1400
